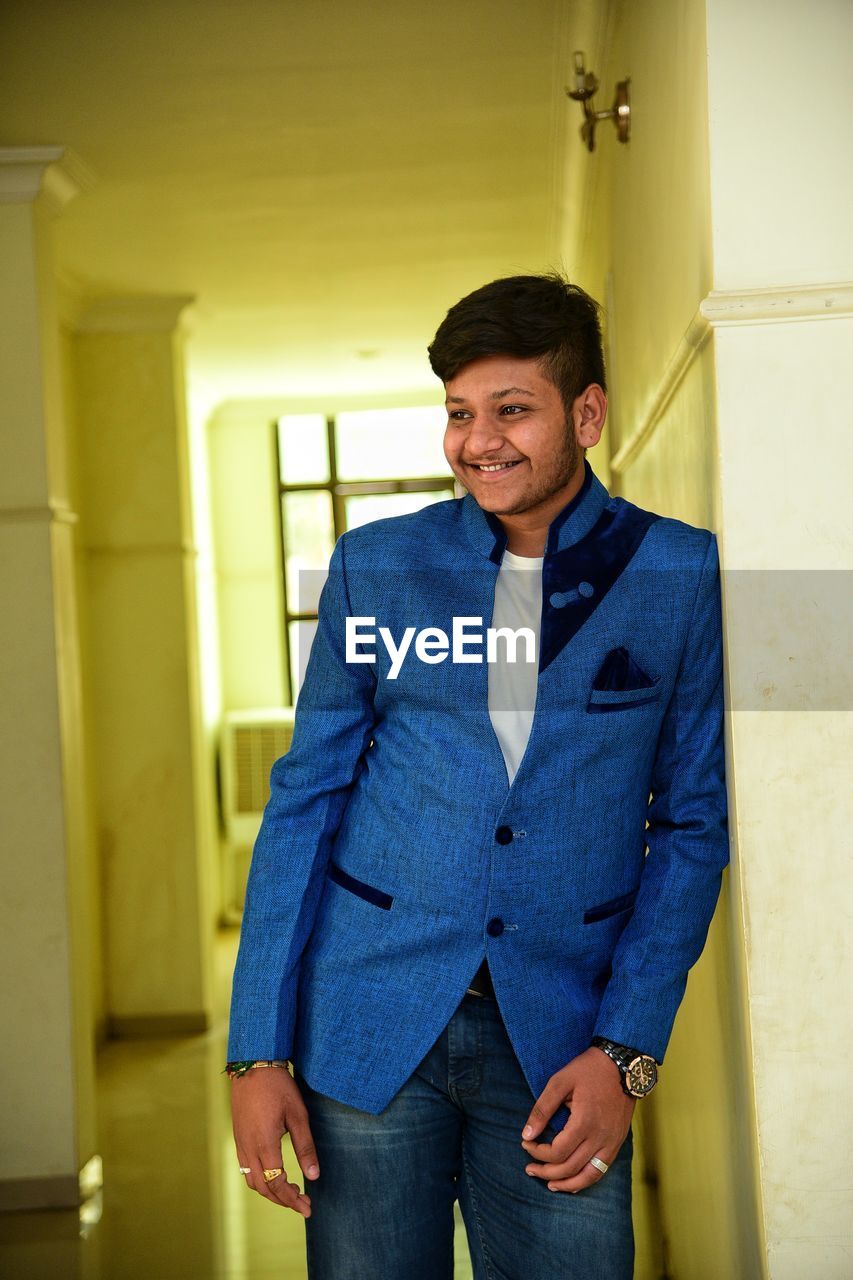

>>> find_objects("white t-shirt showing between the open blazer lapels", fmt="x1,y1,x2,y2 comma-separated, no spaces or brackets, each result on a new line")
489,550,544,783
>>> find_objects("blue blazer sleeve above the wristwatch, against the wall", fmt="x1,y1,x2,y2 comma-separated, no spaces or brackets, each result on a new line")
594,534,729,1062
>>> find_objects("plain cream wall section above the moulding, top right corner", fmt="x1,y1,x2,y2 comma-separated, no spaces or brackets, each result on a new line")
707,0,853,291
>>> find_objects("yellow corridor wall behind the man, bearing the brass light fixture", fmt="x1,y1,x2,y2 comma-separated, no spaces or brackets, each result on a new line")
562,0,762,1280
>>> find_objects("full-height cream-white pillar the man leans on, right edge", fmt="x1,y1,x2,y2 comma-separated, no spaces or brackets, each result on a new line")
702,0,853,1280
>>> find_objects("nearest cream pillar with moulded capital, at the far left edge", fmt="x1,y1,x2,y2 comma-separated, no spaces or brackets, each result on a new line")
0,147,99,1208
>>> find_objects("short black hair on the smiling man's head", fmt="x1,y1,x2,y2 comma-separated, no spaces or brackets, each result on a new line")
427,271,607,415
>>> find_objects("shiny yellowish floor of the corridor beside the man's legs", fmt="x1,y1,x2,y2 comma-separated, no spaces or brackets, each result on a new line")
0,931,471,1280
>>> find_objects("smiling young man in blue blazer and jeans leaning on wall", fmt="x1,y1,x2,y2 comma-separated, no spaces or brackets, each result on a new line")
228,275,727,1280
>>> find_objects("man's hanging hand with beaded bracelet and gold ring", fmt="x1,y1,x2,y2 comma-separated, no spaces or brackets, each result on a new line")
231,1066,320,1217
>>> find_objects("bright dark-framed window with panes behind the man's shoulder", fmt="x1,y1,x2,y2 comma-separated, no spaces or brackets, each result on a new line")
275,406,453,703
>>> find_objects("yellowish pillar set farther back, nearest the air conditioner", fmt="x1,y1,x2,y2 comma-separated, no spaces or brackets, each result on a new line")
73,297,216,1036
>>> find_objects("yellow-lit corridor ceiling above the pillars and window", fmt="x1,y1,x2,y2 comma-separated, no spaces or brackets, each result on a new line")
0,0,574,401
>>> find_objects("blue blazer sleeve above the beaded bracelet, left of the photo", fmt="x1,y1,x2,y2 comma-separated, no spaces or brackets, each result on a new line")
228,534,377,1062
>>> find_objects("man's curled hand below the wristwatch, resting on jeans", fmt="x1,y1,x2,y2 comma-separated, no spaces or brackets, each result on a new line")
521,1047,637,1192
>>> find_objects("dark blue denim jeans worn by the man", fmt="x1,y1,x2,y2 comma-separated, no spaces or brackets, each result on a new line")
295,995,634,1280
